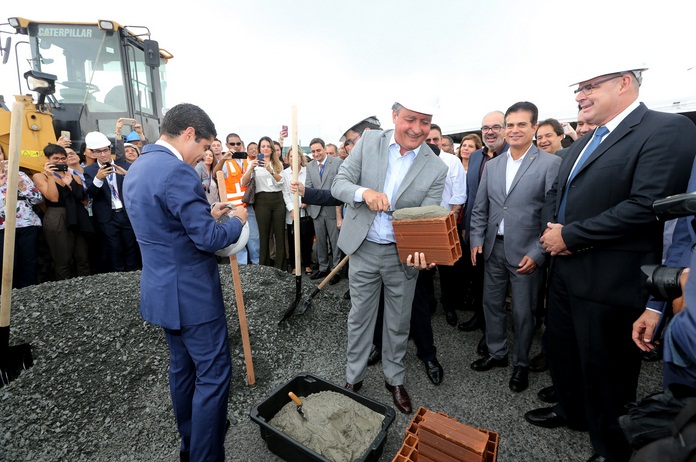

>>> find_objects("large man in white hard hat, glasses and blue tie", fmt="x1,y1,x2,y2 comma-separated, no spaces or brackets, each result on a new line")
525,65,696,461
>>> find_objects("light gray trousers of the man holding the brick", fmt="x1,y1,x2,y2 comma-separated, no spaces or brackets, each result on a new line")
346,240,418,385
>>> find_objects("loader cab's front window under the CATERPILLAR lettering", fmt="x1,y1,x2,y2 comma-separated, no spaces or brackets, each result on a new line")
29,24,127,113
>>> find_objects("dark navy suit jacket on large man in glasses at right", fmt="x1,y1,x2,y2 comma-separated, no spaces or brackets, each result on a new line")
541,103,696,308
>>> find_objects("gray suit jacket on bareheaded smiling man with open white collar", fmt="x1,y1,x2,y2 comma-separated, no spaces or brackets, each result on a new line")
470,146,561,266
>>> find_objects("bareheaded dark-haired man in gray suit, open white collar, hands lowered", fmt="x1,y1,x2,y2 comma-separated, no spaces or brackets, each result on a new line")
470,101,561,392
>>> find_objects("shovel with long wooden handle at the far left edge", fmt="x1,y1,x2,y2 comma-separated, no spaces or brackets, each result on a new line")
0,102,34,388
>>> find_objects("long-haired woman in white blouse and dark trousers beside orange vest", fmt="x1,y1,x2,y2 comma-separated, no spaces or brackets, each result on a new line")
242,136,288,270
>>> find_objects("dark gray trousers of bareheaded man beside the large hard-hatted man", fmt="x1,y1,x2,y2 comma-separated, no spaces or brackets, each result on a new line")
483,239,542,367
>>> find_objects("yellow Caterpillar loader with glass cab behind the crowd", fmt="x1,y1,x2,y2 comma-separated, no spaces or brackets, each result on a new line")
0,18,173,171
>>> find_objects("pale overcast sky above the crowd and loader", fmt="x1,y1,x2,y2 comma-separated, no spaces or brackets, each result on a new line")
0,0,696,144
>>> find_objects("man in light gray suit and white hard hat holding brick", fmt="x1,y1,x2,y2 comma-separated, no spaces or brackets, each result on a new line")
331,100,447,414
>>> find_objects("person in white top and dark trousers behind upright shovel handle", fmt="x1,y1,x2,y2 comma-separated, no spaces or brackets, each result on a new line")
283,149,314,275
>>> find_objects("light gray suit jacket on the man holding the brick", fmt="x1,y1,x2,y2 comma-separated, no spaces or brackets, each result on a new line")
331,130,447,258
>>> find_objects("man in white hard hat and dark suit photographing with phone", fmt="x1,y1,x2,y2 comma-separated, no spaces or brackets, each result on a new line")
85,132,140,271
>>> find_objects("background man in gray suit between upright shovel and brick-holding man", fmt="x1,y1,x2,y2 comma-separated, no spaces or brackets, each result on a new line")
306,138,342,284
